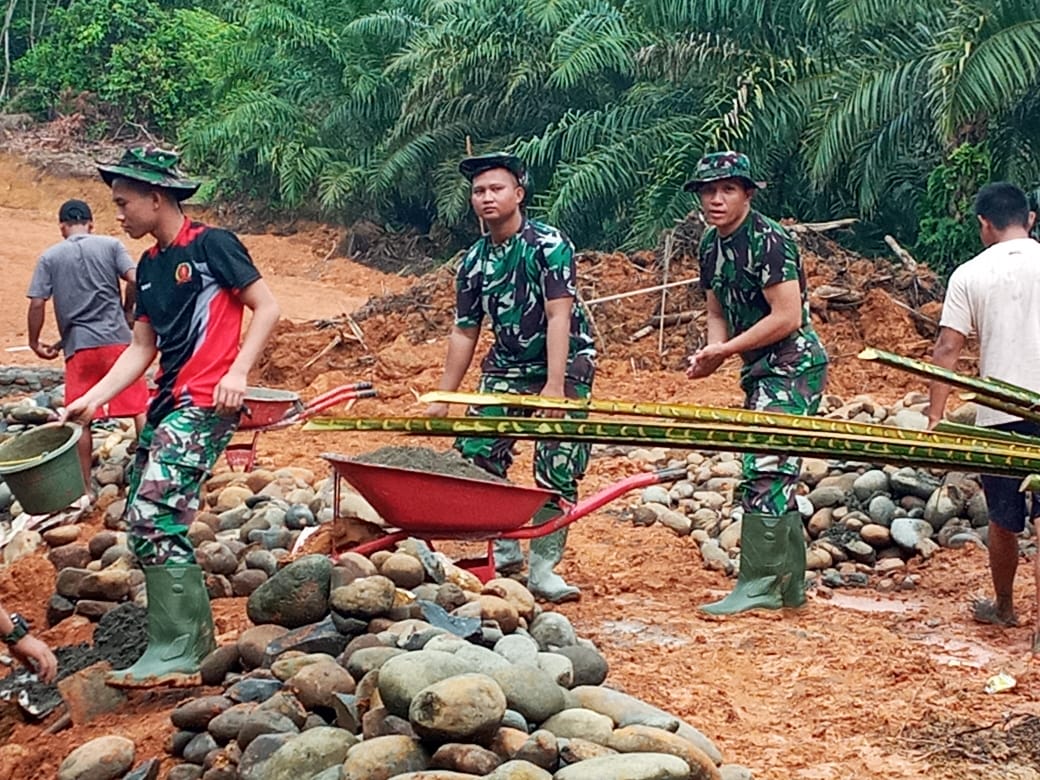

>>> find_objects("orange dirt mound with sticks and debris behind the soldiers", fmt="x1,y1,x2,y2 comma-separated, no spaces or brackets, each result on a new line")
258,220,942,396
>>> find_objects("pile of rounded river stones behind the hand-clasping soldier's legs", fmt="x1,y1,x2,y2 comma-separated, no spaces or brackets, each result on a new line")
627,393,1002,592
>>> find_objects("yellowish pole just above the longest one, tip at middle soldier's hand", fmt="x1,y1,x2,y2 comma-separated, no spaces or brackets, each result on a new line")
419,390,1040,456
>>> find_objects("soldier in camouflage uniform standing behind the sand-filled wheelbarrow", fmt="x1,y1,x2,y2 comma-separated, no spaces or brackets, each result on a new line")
427,154,596,601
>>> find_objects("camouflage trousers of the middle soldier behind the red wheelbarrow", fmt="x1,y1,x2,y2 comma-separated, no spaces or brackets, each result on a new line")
454,374,592,501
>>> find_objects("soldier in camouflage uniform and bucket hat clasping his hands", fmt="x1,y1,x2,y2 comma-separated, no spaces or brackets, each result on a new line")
685,152,827,615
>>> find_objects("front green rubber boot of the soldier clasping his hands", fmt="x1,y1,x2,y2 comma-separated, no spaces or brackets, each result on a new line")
700,512,790,615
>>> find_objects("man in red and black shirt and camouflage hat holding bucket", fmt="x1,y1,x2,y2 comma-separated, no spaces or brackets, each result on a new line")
66,148,279,685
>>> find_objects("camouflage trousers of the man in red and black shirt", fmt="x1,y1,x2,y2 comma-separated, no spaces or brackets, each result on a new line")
126,407,238,566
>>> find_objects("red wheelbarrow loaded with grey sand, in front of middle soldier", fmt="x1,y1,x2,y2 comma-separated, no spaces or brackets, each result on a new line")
321,452,686,582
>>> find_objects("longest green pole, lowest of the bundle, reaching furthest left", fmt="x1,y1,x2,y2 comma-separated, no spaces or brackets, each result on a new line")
305,417,1040,477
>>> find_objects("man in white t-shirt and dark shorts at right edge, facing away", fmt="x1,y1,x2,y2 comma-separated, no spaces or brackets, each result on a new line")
928,182,1040,632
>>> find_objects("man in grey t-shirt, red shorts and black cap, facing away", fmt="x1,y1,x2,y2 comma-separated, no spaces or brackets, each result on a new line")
27,200,148,496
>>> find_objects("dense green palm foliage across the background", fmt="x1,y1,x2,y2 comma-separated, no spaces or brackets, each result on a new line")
2,0,1040,271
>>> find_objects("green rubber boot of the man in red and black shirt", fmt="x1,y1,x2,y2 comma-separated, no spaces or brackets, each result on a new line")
107,564,216,687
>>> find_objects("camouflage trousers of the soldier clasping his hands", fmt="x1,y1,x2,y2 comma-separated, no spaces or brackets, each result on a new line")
738,364,827,515
